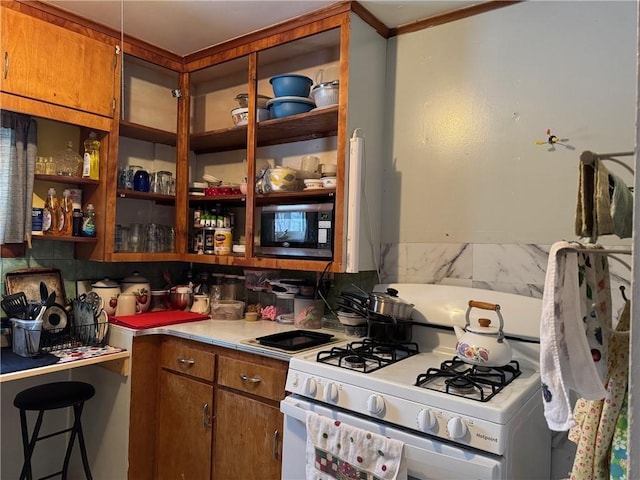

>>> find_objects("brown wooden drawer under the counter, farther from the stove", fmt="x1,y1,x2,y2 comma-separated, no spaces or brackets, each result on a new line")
160,340,216,382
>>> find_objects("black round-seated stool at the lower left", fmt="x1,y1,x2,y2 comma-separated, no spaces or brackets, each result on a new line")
13,382,96,480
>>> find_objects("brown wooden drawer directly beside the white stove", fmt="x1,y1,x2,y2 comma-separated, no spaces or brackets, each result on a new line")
218,357,287,401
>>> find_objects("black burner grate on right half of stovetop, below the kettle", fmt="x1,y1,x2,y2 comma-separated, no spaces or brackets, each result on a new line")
415,358,522,402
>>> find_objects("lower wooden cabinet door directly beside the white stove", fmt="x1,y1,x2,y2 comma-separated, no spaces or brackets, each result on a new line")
213,389,283,480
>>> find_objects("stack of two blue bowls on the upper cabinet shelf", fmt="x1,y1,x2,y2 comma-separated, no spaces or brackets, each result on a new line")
267,74,316,118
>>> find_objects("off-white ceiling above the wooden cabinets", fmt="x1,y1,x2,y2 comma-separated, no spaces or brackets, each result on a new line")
44,0,483,56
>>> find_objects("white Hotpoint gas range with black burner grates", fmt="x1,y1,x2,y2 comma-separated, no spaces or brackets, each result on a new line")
281,284,551,480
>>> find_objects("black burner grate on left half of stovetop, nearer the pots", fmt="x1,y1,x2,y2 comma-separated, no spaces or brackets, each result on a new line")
316,338,419,373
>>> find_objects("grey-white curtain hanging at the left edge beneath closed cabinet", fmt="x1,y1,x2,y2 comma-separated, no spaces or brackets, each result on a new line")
0,111,38,244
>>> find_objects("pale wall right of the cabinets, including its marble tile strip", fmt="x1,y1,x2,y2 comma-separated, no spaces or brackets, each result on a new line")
382,1,637,308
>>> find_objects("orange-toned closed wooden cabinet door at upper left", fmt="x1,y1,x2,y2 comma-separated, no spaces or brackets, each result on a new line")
0,8,119,117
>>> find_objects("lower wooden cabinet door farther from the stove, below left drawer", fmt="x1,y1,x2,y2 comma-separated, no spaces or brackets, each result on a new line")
154,370,213,480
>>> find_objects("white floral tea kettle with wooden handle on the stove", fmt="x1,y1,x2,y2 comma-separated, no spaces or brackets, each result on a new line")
453,300,512,367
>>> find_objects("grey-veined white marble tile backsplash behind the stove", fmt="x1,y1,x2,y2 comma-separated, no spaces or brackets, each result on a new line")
380,243,631,318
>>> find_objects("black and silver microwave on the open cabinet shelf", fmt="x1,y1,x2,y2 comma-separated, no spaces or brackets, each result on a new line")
256,203,334,259
